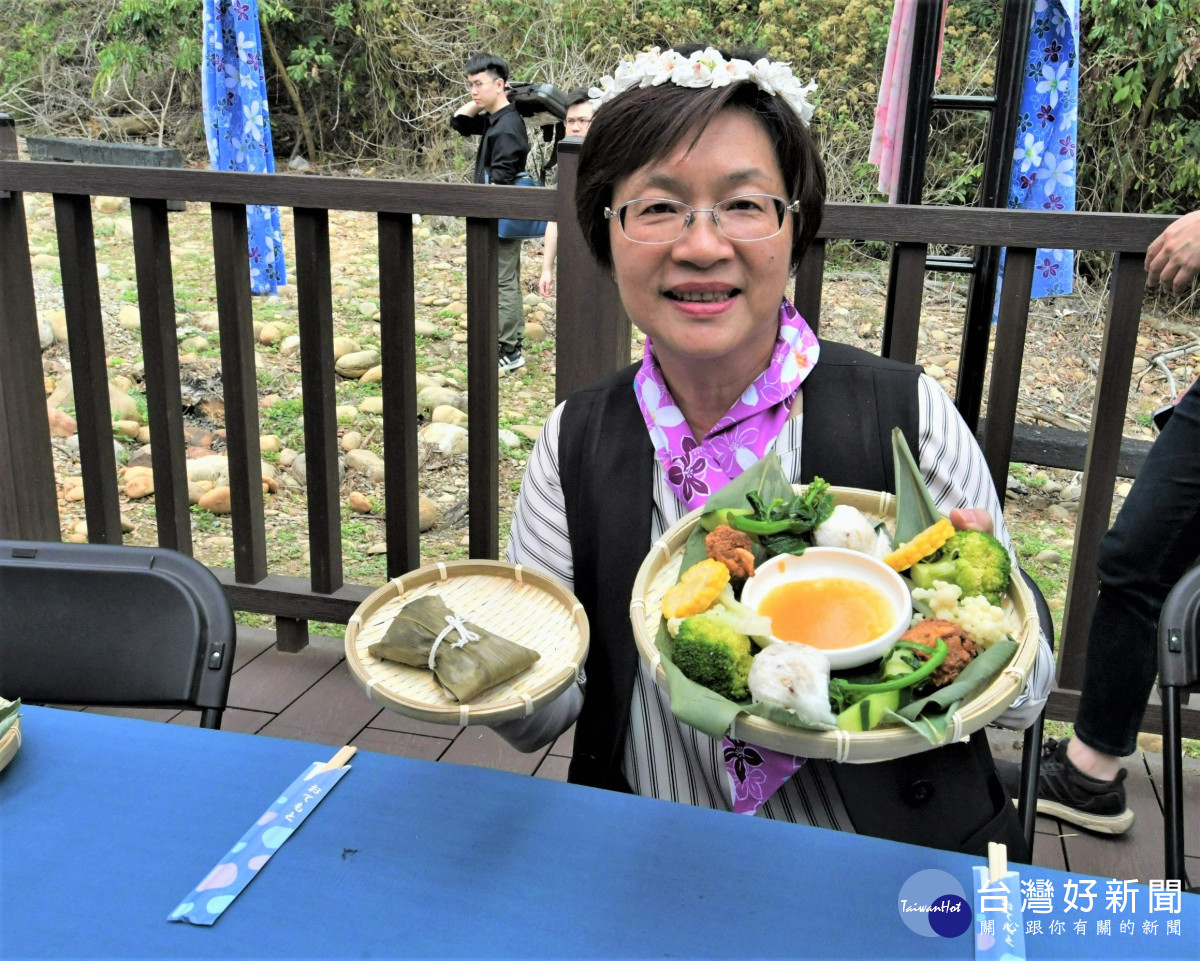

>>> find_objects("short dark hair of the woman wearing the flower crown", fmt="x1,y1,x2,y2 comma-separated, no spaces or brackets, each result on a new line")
575,46,826,270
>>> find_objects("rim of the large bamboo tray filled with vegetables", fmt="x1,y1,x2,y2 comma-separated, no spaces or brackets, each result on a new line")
629,487,1039,763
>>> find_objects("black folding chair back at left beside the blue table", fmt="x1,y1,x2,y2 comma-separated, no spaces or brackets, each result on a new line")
0,541,235,727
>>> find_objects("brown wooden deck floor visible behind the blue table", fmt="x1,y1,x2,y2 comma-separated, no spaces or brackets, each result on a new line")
91,627,1200,883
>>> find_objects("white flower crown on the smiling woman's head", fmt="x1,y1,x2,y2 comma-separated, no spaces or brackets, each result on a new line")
588,47,817,126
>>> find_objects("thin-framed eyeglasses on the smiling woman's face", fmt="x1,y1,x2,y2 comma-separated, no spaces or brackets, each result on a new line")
604,193,800,244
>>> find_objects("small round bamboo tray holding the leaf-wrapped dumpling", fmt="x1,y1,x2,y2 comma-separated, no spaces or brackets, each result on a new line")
346,560,588,727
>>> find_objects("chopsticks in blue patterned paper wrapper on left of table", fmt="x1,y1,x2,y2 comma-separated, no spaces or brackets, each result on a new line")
167,746,358,925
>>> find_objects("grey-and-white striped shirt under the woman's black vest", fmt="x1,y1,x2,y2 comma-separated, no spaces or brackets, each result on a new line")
508,376,1054,830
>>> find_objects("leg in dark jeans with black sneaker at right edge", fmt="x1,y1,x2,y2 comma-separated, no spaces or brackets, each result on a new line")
1039,382,1200,830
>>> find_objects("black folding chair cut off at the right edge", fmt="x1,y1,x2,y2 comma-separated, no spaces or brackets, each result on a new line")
1158,567,1200,884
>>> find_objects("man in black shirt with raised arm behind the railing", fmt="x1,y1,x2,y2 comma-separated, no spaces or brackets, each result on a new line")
450,54,529,371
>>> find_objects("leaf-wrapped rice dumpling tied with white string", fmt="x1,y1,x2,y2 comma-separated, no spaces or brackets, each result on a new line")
367,594,541,701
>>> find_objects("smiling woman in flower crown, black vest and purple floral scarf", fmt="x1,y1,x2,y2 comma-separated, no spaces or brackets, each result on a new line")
497,48,1052,859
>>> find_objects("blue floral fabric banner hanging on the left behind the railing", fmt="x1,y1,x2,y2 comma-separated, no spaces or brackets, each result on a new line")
202,0,288,294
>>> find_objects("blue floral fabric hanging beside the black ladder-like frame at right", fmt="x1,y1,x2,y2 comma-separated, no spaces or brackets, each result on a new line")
992,0,1079,319
